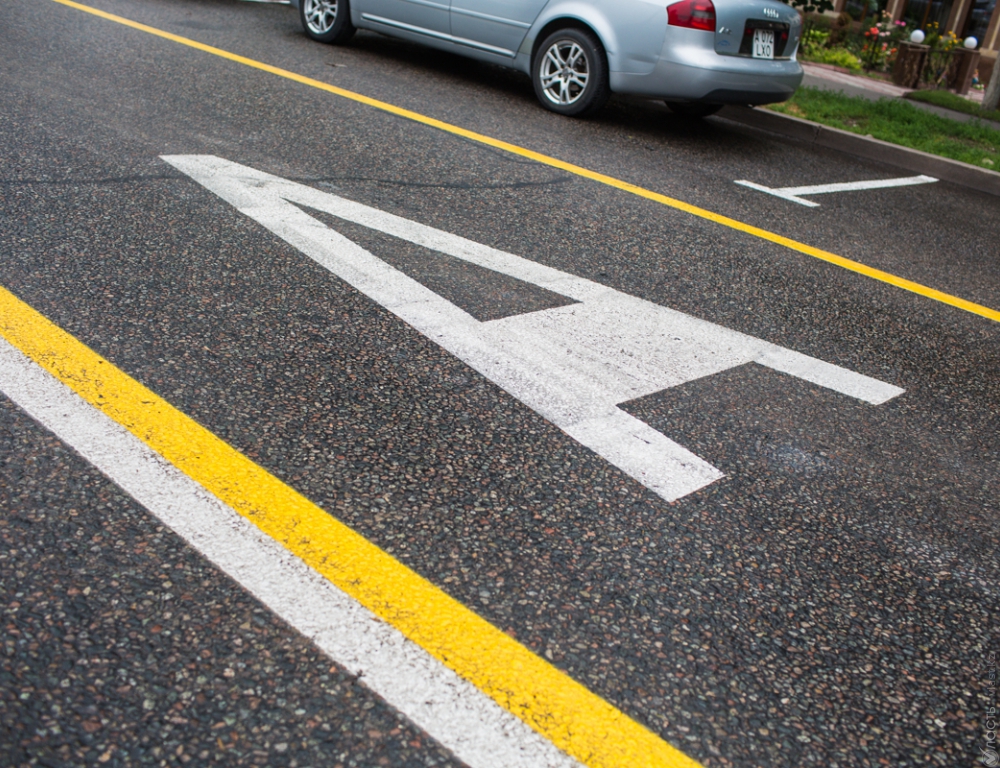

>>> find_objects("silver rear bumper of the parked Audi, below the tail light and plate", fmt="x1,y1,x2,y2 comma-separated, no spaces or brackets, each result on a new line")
611,28,803,104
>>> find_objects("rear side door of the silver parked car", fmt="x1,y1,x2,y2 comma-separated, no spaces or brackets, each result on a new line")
451,0,549,56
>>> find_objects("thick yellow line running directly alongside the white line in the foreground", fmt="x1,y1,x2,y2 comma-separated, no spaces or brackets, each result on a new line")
0,287,698,768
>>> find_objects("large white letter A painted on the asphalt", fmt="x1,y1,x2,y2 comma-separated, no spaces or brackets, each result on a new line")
163,155,903,501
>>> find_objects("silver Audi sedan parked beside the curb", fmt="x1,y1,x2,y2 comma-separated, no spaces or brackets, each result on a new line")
292,0,802,116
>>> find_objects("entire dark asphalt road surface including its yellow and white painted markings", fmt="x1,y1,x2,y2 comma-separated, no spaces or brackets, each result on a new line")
0,0,1000,766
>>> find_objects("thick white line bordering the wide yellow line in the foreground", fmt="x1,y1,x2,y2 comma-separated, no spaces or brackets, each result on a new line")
0,337,580,768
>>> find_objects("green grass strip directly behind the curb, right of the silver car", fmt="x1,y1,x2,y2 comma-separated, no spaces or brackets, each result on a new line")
769,87,1000,170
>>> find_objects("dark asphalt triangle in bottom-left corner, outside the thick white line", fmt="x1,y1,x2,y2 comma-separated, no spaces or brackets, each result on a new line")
0,398,460,767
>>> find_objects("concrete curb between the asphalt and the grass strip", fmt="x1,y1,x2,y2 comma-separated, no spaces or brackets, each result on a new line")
719,107,1000,197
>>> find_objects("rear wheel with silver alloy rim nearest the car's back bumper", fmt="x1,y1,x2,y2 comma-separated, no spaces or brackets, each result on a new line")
531,27,611,117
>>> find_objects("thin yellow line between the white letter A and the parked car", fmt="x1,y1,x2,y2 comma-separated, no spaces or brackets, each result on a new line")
54,0,1000,322
